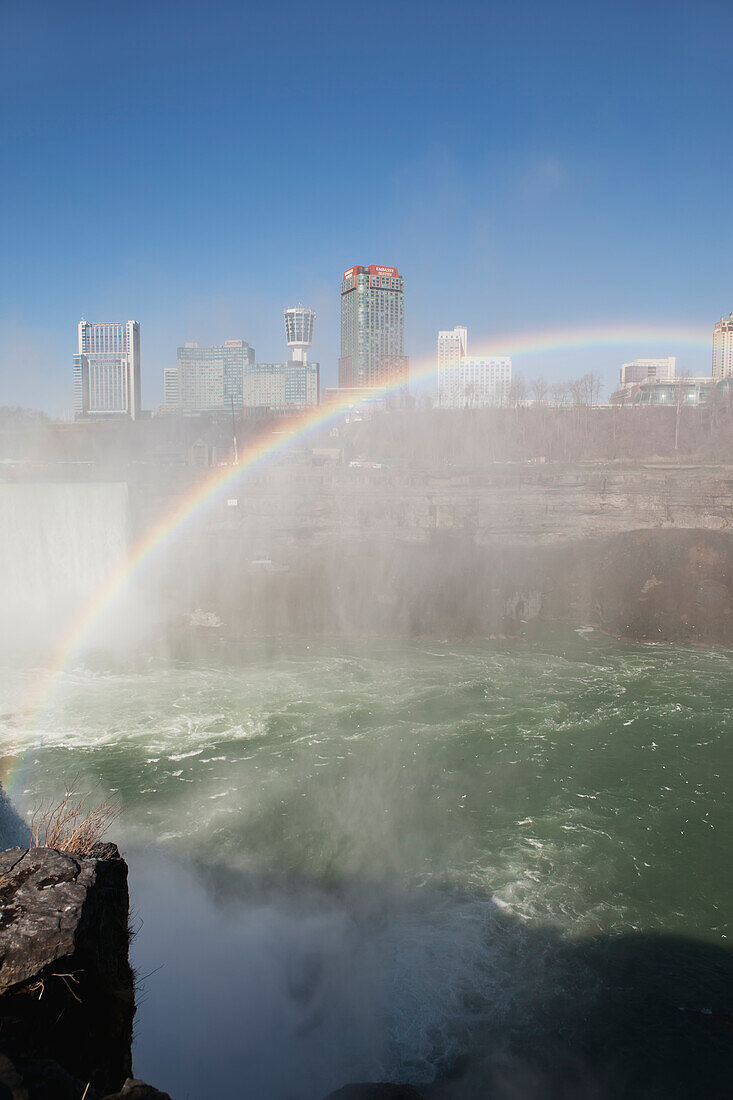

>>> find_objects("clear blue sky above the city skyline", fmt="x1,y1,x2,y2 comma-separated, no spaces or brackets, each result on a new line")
0,0,733,413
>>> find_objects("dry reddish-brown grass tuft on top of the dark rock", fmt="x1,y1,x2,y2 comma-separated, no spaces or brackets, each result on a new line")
30,782,122,856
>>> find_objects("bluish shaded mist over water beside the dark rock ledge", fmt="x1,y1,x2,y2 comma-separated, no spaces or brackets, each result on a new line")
127,856,590,1100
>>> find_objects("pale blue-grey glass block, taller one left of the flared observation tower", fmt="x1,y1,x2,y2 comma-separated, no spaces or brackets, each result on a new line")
177,340,254,413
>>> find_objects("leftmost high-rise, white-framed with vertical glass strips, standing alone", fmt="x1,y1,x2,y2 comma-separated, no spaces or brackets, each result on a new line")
74,318,141,420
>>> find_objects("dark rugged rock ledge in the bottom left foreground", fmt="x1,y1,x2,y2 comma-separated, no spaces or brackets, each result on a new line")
0,844,169,1100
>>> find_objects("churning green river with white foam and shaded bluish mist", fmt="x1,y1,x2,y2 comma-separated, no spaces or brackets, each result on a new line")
0,635,733,1100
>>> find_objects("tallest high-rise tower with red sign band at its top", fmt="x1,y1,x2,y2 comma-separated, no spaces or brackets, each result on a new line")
339,264,409,389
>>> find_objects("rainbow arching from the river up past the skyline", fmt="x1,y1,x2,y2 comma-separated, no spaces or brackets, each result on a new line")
4,325,710,793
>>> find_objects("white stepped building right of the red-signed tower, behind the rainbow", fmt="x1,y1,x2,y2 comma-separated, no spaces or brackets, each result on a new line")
438,325,512,409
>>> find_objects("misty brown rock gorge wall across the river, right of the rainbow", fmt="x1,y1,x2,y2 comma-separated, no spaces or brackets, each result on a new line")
131,462,733,645
